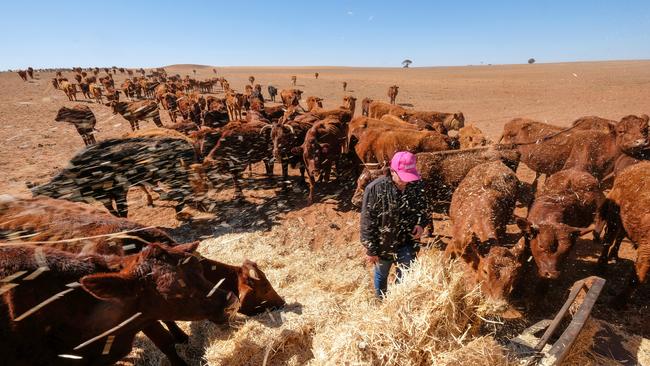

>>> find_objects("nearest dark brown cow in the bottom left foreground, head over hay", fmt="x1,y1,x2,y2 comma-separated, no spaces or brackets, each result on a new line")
0,243,238,365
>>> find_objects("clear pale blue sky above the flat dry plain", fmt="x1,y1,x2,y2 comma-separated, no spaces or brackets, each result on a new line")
0,0,650,69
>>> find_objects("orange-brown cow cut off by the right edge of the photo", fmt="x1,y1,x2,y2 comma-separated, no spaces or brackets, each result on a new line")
601,161,650,307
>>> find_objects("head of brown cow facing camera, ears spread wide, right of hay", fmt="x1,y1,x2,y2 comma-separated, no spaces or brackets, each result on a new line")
517,218,588,279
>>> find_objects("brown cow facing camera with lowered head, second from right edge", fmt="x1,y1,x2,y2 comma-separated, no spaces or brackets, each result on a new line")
517,169,605,279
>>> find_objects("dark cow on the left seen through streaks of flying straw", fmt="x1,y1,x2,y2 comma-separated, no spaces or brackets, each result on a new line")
32,137,207,217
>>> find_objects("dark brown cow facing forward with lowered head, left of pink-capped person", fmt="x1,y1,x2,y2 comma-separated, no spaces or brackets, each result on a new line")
294,119,346,204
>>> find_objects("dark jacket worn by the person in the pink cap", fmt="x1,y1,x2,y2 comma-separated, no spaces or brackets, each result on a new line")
361,177,430,259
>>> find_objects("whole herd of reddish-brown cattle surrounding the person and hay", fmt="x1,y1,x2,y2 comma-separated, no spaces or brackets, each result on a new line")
0,68,650,364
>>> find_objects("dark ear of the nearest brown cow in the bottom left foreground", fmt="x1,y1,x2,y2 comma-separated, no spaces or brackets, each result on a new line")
79,273,137,300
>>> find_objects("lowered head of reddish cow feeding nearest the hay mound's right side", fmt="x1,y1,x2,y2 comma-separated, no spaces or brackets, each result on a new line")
476,237,526,300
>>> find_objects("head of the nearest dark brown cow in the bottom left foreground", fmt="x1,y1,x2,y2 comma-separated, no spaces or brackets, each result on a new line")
79,242,238,322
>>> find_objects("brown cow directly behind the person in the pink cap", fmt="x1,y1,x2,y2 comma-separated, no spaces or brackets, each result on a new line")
352,146,519,206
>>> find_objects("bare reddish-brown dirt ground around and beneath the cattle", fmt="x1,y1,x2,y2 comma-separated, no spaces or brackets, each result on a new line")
0,61,650,363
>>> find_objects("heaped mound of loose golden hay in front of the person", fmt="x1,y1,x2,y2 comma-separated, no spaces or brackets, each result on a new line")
314,251,505,365
